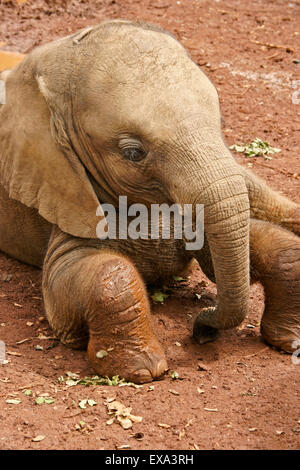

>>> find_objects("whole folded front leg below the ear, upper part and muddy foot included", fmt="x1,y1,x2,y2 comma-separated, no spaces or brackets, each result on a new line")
43,228,167,383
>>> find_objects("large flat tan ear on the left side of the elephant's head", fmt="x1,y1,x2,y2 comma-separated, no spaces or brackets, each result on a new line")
0,41,104,238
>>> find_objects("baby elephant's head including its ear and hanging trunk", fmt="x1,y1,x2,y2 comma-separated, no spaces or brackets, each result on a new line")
0,21,249,328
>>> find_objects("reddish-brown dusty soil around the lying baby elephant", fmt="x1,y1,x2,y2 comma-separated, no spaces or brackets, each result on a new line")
0,0,300,449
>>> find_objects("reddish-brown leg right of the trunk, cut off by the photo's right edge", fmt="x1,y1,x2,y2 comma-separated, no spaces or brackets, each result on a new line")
250,221,300,353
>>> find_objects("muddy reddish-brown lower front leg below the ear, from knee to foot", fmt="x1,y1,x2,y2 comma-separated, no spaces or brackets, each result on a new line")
88,253,167,383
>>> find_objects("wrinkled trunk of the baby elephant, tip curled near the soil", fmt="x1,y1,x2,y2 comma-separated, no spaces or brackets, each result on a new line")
168,142,250,329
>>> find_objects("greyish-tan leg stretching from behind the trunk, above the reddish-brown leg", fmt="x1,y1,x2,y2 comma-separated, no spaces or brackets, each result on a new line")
240,166,300,235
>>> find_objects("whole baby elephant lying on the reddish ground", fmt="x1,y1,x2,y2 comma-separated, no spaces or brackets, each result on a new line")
0,21,300,383
